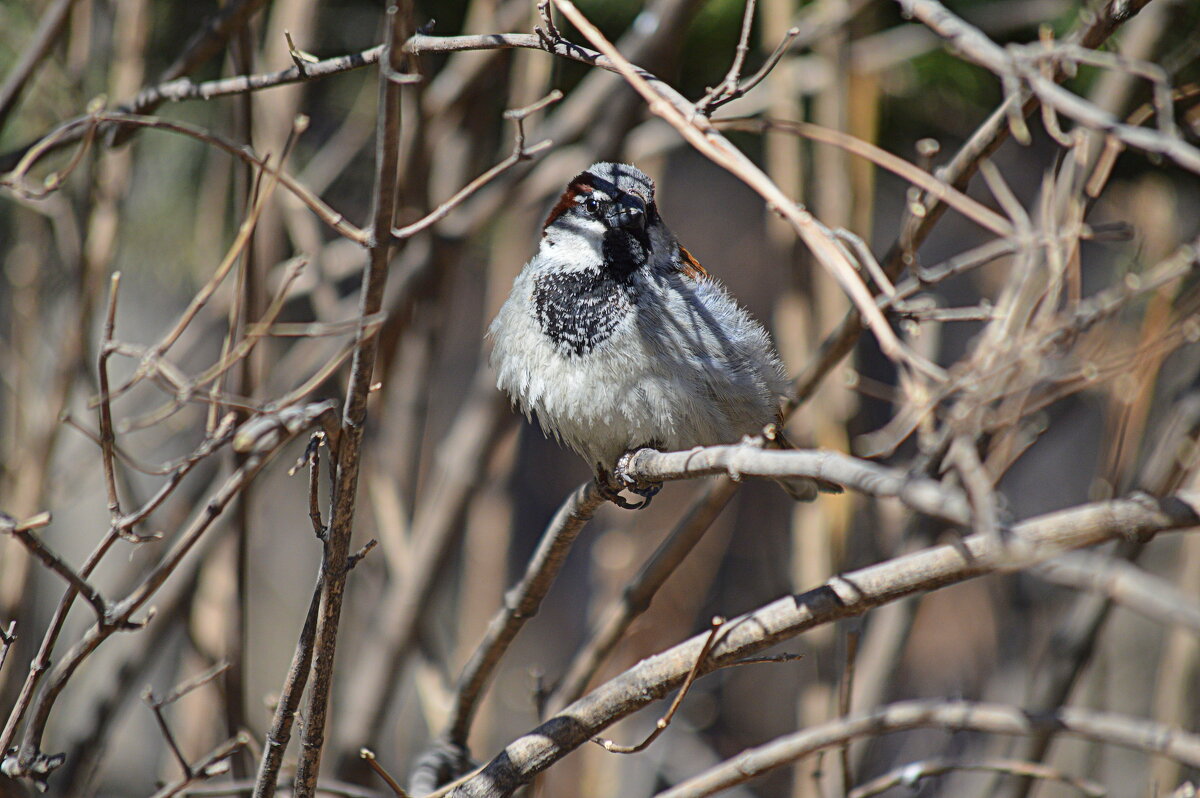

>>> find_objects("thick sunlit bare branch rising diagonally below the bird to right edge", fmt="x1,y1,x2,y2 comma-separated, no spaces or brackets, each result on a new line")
450,494,1200,798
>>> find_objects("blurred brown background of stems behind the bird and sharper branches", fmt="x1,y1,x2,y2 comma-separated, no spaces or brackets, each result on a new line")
0,0,1200,798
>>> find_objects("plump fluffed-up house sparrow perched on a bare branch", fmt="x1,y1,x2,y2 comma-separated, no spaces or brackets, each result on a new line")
487,163,840,508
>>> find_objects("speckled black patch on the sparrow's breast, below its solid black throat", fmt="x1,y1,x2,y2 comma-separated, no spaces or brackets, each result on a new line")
533,271,634,356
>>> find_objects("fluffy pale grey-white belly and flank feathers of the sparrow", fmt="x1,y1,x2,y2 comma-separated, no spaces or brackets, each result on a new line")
491,273,778,470
